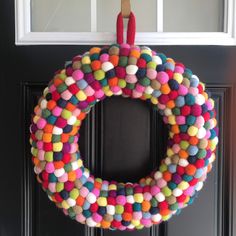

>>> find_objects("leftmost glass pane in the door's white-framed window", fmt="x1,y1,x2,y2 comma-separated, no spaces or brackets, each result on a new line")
31,0,91,32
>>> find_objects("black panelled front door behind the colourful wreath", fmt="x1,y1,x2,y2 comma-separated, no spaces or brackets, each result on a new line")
0,0,236,236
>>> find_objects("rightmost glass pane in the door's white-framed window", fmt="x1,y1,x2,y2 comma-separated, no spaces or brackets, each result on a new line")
163,0,224,32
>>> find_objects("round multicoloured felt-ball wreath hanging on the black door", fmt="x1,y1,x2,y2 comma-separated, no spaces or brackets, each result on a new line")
30,44,218,230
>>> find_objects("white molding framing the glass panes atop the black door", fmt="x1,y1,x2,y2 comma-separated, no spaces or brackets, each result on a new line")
15,0,236,45
